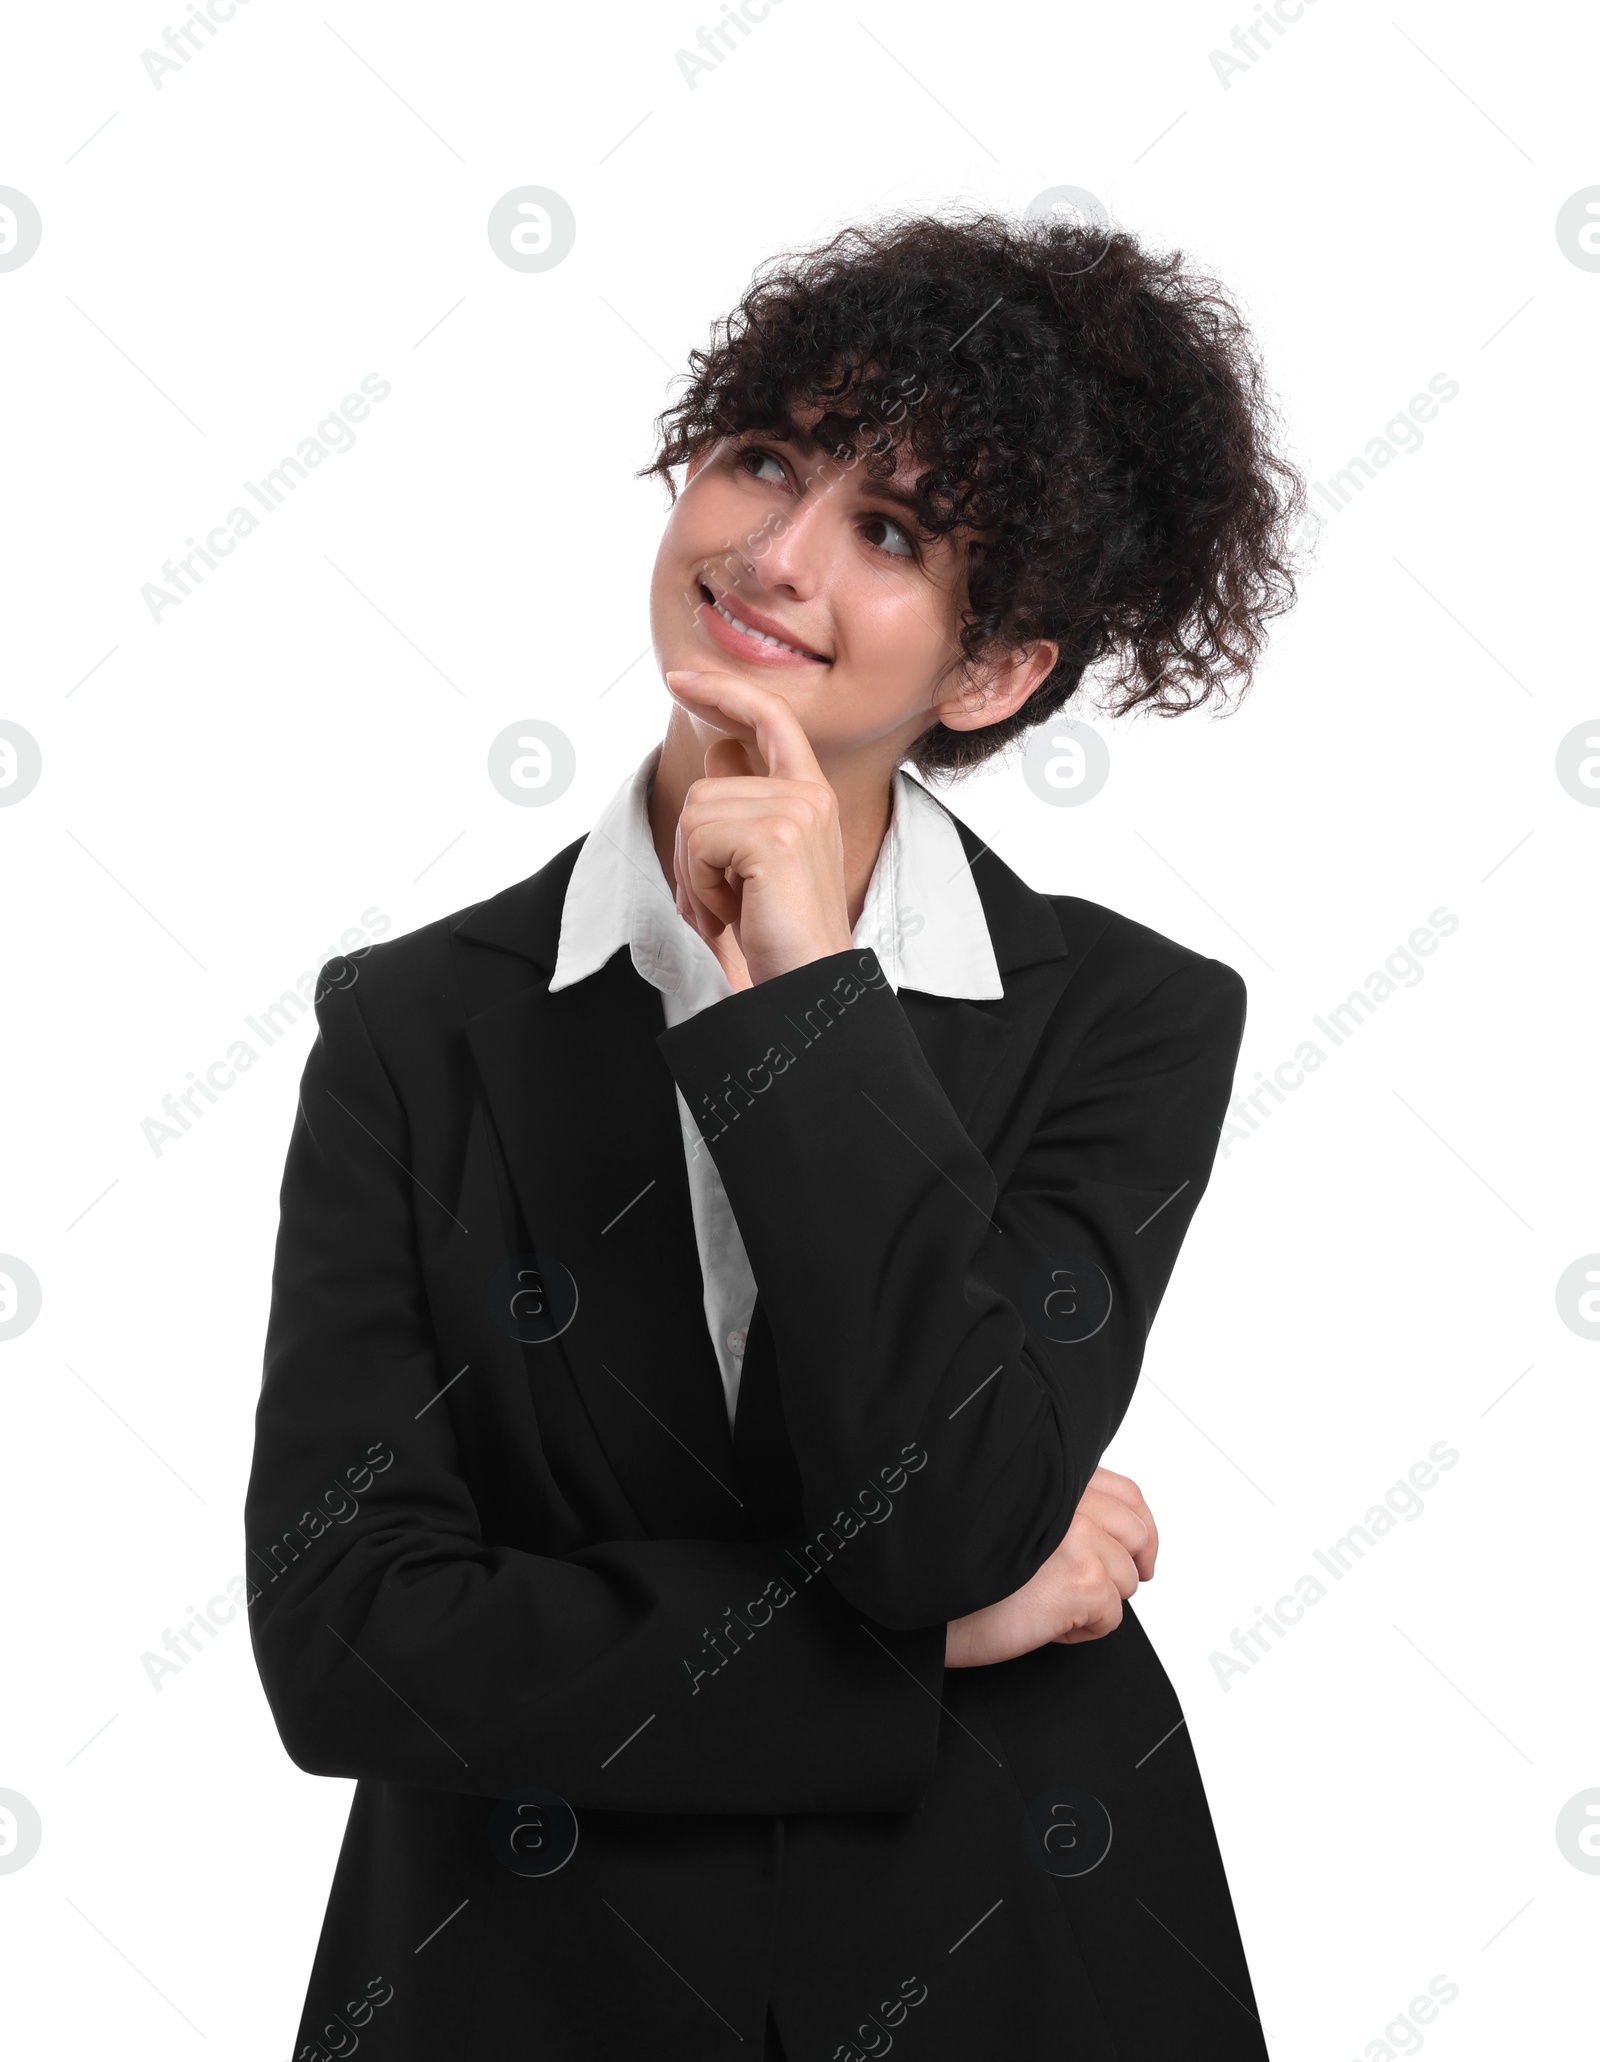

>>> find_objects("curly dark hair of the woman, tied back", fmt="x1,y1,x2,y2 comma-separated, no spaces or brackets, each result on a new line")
641,212,1305,775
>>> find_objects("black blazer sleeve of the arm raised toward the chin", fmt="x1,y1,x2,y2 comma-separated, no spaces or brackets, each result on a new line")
658,949,1245,1627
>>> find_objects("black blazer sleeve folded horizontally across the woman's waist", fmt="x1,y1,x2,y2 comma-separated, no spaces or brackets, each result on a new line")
245,960,944,1815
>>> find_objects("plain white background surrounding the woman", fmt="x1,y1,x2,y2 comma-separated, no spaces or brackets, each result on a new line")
0,0,1600,2062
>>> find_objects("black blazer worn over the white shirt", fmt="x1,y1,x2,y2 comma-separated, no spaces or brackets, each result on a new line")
245,804,1266,2062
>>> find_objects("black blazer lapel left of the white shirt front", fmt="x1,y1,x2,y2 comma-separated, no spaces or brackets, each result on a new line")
456,845,748,1538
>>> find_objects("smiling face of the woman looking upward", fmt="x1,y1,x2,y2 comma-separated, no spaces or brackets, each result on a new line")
649,419,1056,763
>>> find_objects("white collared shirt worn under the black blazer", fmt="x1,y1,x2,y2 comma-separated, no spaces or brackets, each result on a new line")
551,744,1004,1427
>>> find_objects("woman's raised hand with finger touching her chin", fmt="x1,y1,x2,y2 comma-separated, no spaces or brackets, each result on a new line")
666,672,852,982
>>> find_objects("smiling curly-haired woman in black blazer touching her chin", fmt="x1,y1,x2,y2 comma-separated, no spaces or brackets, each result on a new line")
245,217,1299,2062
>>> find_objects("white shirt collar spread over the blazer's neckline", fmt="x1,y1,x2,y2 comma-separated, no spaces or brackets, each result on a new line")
551,744,1004,1002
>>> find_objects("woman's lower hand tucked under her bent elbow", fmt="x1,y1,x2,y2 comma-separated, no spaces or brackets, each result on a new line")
944,1468,1159,1668
